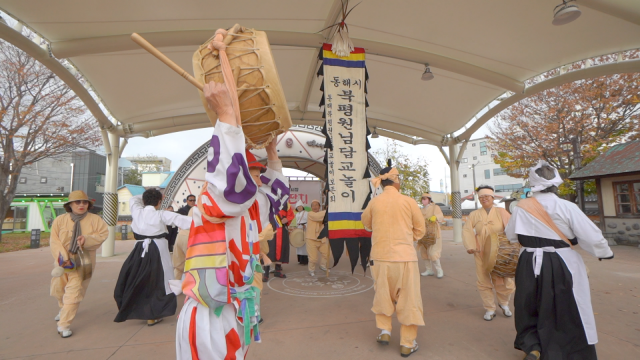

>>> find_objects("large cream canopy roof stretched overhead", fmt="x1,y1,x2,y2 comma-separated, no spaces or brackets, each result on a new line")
0,0,640,145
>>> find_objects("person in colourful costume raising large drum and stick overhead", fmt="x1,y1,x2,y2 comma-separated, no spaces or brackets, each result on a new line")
131,24,291,360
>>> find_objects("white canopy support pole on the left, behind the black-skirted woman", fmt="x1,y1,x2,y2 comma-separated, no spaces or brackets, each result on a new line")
102,133,120,257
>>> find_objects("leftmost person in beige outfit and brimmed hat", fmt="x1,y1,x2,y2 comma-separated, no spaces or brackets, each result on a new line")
49,190,109,338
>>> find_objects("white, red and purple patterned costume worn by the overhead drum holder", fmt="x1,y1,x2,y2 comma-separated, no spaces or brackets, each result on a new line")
176,121,289,360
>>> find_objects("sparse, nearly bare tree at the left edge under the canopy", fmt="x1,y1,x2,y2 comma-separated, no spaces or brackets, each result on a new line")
0,40,100,239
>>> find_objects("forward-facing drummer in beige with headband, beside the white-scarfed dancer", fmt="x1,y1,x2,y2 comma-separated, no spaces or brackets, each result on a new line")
462,185,515,321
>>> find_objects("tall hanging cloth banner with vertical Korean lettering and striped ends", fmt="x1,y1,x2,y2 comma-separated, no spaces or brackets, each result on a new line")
319,44,371,272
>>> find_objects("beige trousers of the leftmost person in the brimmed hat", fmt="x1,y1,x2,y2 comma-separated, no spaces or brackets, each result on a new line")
51,271,89,331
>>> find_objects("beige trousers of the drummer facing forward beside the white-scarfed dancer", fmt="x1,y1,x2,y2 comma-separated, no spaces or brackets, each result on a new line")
474,254,516,311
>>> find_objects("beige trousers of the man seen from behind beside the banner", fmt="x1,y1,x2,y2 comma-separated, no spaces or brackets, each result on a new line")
371,260,424,347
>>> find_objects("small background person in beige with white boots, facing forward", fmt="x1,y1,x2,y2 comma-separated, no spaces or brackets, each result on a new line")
418,193,444,279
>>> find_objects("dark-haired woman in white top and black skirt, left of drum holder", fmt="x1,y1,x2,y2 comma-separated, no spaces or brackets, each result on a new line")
113,189,191,326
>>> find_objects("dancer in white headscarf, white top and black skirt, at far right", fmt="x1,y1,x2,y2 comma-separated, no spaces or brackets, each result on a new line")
505,161,613,360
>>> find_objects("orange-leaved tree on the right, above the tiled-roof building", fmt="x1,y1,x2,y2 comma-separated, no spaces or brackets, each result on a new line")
489,52,640,198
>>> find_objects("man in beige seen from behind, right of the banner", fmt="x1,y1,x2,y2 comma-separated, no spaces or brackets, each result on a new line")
362,166,425,357
